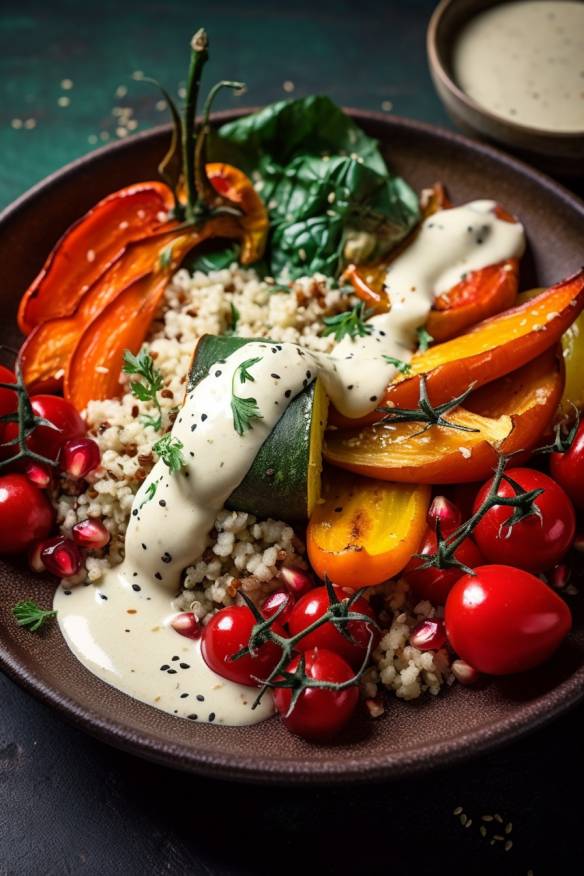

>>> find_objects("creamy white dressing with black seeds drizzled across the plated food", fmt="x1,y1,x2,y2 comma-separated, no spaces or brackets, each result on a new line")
54,201,524,725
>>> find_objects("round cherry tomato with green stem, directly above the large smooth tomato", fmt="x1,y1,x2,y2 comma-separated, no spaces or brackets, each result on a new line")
473,468,576,572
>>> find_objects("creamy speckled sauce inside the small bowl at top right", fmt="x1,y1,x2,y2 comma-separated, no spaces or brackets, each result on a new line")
453,0,584,132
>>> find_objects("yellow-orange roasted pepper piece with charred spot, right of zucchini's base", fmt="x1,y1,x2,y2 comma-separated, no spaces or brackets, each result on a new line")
306,471,430,590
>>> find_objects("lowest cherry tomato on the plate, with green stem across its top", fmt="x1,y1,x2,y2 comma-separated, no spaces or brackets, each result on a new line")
274,648,359,740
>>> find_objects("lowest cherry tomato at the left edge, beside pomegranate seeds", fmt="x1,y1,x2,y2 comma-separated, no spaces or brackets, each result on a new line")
0,474,54,554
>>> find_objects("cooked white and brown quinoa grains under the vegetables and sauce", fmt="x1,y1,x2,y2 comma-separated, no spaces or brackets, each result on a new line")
54,265,452,700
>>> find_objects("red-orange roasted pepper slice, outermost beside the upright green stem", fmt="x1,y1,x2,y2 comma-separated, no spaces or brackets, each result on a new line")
18,182,173,334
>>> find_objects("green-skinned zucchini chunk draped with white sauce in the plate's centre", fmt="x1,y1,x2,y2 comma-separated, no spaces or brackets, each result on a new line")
189,335,328,521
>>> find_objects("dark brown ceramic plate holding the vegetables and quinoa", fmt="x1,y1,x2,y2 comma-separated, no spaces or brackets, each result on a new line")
0,112,584,783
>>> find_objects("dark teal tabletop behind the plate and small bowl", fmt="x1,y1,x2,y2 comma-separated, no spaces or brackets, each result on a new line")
0,0,446,206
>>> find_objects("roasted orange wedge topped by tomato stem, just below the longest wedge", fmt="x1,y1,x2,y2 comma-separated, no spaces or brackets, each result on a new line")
324,348,564,484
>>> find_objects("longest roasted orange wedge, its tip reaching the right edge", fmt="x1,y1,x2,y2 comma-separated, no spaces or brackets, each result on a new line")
329,270,584,427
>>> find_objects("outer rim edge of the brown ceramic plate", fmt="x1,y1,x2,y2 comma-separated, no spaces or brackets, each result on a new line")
0,107,584,785
